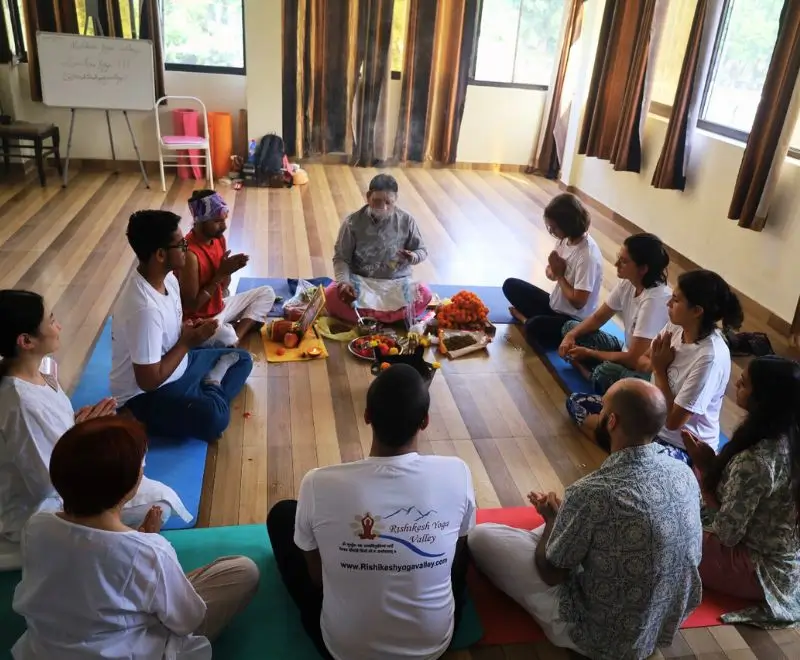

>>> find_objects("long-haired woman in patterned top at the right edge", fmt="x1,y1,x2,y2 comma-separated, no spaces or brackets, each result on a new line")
683,356,800,628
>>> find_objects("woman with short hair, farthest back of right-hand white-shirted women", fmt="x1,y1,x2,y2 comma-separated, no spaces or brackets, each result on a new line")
503,193,603,351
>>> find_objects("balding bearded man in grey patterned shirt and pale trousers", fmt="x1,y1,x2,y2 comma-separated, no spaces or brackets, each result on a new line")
469,379,703,660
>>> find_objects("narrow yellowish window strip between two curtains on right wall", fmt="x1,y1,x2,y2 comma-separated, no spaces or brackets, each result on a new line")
650,0,697,117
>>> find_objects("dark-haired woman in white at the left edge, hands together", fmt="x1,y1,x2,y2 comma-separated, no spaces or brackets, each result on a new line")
0,289,192,552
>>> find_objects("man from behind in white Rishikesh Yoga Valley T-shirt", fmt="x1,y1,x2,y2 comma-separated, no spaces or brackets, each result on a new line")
267,365,475,660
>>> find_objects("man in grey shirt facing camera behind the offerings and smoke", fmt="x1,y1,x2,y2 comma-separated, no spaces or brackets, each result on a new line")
325,174,432,323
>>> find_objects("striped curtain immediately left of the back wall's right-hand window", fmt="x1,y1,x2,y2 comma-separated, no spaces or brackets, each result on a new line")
394,0,478,163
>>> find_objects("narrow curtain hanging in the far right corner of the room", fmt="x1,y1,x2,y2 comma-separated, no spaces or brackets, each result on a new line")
527,0,585,179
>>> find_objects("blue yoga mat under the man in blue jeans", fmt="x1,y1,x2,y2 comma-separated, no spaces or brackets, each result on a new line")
72,319,208,529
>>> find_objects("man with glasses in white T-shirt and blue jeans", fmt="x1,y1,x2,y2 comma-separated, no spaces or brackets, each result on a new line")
111,211,253,441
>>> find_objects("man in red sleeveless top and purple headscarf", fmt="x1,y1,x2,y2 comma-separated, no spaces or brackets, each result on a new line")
178,190,275,346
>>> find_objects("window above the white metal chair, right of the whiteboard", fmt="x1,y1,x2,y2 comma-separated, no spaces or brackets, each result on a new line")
162,0,245,74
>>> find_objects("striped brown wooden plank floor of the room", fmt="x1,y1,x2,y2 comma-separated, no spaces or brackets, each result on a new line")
0,165,800,660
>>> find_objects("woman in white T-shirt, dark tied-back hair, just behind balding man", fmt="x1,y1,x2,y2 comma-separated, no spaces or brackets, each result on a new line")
567,270,743,464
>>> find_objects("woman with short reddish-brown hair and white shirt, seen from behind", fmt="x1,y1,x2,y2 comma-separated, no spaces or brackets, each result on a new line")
12,417,259,660
